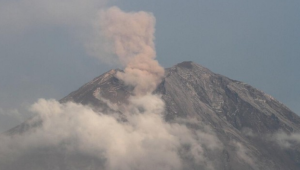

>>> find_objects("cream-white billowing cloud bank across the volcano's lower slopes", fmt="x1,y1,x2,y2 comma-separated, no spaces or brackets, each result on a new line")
0,95,220,170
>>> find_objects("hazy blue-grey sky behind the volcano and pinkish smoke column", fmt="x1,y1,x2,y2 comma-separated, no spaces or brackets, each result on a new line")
0,0,300,132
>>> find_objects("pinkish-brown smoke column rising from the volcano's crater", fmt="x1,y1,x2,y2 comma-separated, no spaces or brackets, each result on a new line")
100,7,164,96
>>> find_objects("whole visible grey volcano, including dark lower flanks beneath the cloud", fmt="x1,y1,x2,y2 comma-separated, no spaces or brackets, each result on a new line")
0,62,300,170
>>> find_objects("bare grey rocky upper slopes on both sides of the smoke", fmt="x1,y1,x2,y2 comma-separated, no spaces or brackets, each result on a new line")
61,62,300,169
